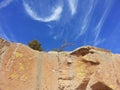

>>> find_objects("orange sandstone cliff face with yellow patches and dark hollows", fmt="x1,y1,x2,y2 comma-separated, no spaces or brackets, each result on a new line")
0,39,120,90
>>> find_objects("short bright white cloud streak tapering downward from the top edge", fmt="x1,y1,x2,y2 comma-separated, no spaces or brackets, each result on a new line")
68,0,78,15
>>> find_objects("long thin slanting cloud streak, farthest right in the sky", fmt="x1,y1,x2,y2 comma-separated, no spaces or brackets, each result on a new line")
94,0,113,45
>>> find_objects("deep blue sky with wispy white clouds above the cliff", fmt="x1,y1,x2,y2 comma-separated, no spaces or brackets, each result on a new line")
0,0,120,53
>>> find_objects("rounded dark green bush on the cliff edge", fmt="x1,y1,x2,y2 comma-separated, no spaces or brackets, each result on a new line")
28,40,43,51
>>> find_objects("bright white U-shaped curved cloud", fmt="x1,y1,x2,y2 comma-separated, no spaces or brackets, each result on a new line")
23,2,62,22
